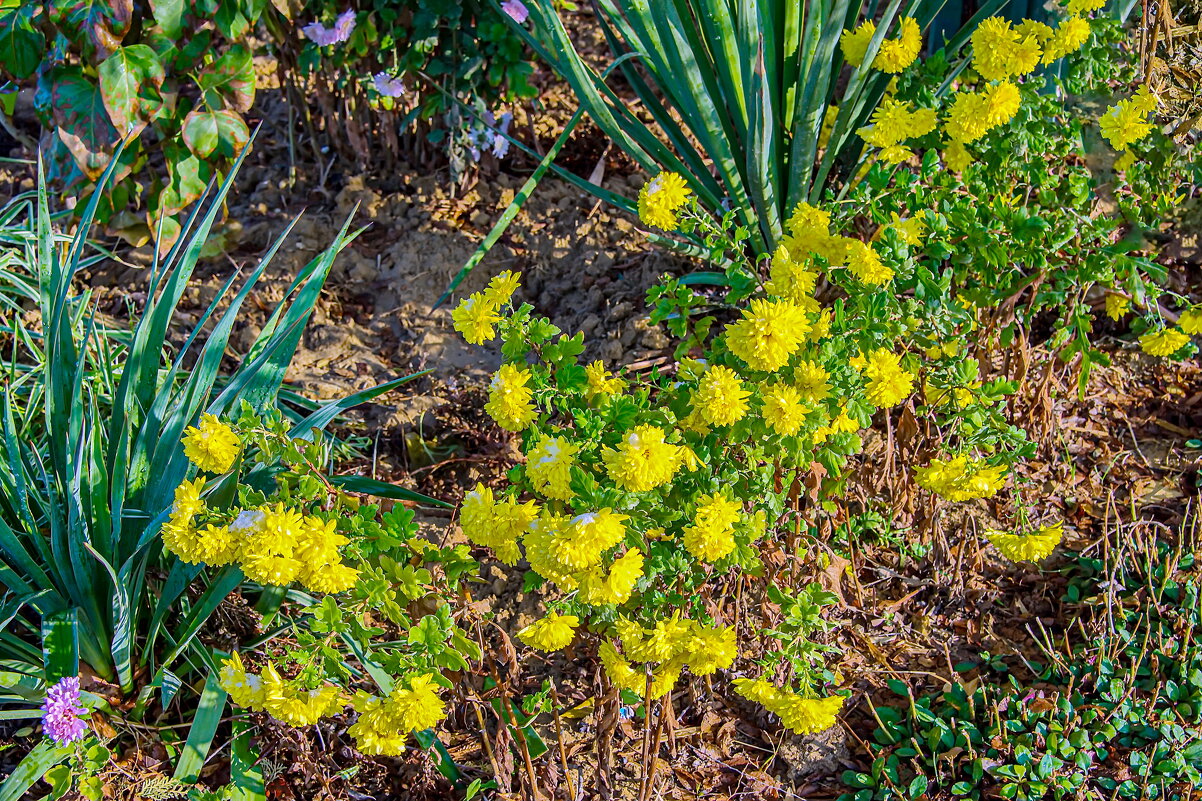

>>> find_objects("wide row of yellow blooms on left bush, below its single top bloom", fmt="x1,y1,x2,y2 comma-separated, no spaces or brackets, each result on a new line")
162,479,358,593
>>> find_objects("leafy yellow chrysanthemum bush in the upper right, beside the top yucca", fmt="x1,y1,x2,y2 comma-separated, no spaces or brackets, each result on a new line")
835,11,1202,375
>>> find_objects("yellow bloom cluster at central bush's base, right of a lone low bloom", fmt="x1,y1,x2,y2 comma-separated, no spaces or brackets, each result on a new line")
597,616,738,698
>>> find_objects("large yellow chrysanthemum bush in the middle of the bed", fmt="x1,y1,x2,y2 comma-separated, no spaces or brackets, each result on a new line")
453,199,1052,732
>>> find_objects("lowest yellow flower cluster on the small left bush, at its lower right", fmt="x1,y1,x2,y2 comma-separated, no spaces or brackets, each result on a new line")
347,674,447,757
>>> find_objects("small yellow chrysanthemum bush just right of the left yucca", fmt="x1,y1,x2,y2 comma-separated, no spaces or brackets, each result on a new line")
162,407,480,754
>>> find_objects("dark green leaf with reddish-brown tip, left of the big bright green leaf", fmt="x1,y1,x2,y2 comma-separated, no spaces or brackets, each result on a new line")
49,66,118,180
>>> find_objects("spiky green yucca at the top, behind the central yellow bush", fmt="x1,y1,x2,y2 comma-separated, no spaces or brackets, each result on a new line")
497,0,1002,254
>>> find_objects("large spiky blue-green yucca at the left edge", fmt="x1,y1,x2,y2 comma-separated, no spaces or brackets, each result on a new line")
0,146,430,799
